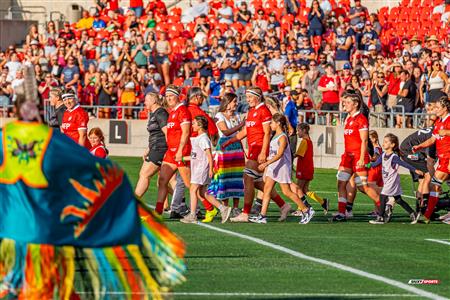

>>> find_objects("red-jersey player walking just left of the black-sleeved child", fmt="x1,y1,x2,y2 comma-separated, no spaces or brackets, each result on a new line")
333,92,379,221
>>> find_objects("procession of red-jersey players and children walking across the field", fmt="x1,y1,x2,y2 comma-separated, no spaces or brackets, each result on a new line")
127,86,450,224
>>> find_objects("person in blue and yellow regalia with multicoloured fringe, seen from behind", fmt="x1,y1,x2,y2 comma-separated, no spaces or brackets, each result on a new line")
0,62,185,299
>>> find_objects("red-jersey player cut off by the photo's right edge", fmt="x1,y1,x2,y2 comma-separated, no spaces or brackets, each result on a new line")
413,97,450,223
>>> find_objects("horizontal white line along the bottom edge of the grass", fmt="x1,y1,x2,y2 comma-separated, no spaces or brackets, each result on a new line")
78,292,419,298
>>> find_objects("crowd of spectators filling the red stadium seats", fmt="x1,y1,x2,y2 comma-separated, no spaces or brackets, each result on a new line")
0,0,450,126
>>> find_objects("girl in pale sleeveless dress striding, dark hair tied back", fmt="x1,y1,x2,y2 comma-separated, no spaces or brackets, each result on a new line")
249,113,315,224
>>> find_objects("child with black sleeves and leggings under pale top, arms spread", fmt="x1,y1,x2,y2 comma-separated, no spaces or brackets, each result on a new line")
367,133,423,224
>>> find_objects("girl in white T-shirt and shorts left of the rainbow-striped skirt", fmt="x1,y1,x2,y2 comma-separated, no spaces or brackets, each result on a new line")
180,116,231,223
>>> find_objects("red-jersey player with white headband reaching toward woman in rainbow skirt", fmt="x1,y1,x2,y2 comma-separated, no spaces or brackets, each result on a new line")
222,87,291,222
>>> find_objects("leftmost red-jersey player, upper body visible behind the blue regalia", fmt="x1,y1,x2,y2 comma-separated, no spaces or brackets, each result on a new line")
61,90,91,149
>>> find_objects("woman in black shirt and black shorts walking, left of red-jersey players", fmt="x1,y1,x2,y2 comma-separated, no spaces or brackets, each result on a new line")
134,92,169,197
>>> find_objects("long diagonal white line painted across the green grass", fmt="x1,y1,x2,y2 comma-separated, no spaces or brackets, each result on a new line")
197,223,447,300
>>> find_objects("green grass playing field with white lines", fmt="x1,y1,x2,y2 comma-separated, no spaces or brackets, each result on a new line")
113,157,450,299
